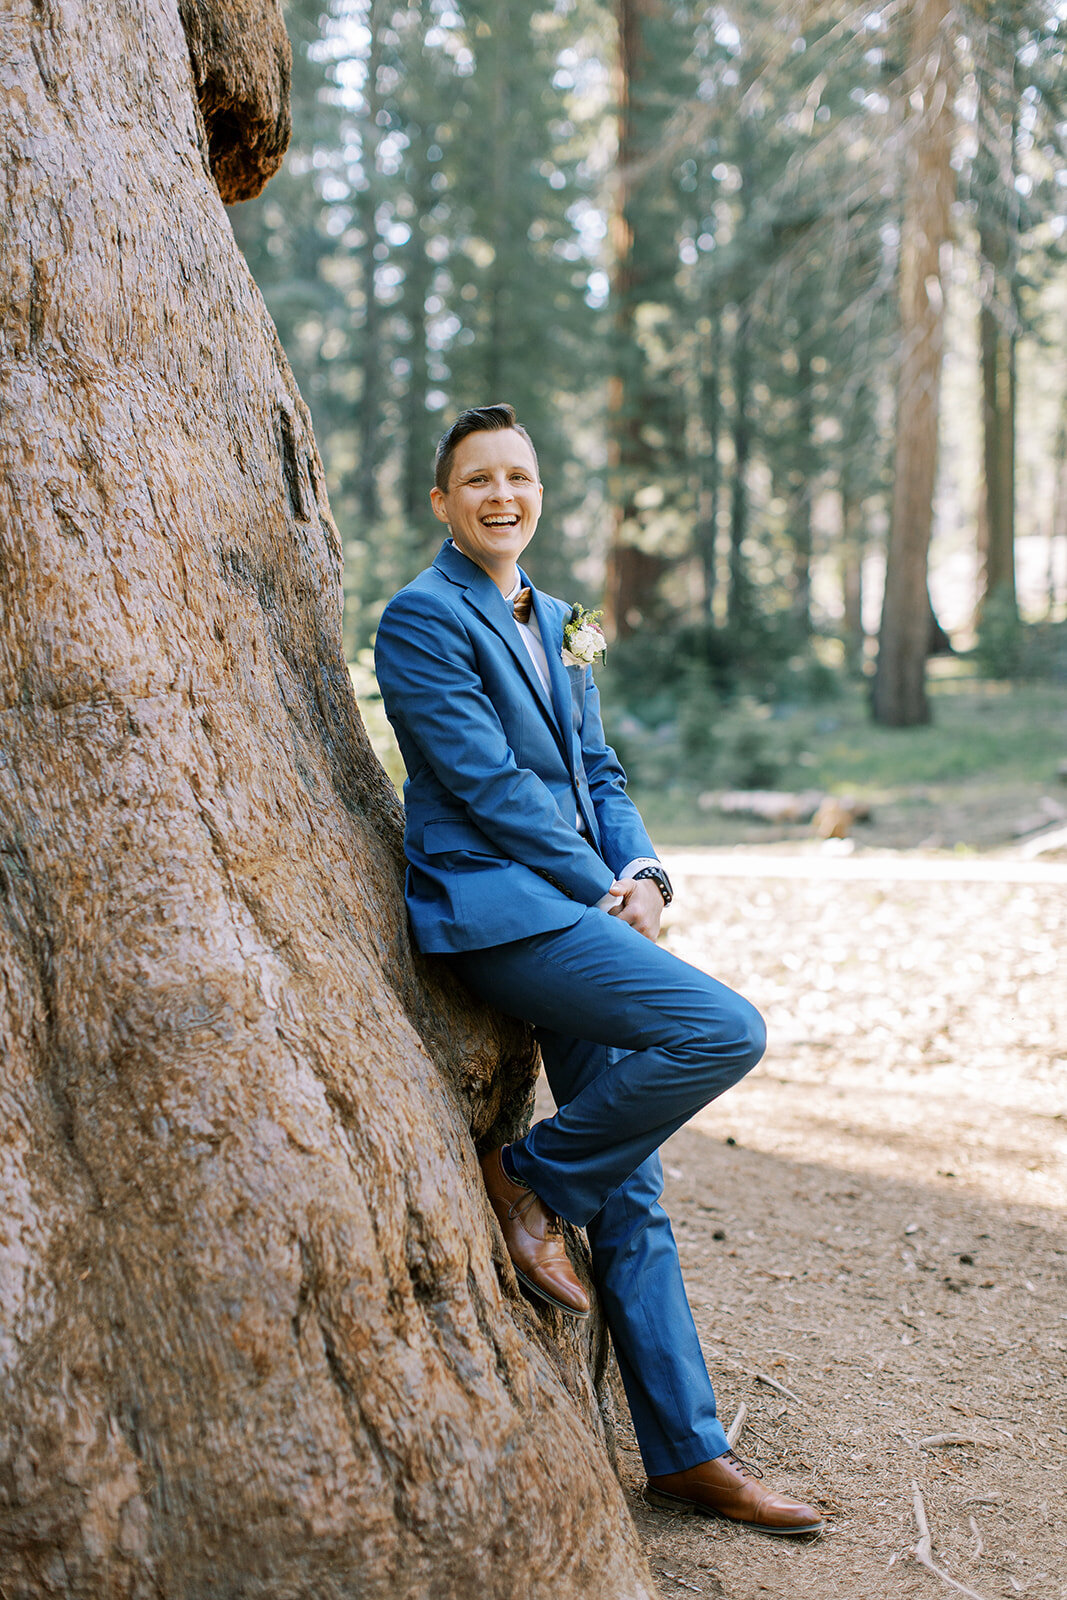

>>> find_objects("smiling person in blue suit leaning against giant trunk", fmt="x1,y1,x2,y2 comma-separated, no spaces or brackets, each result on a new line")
374,405,822,1534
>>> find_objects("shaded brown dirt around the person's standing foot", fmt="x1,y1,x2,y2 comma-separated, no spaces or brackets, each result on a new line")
621,1130,1067,1600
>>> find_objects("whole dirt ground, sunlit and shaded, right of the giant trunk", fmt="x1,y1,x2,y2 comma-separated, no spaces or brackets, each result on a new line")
588,851,1067,1600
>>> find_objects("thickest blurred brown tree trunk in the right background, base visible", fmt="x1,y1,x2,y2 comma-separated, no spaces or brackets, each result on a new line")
872,0,953,726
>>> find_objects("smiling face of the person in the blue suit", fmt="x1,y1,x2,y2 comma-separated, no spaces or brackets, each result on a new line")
430,427,542,595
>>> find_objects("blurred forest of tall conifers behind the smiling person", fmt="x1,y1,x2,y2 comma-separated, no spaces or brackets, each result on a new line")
230,0,1067,837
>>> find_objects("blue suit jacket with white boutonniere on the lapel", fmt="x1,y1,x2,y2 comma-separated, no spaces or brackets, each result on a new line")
374,541,656,950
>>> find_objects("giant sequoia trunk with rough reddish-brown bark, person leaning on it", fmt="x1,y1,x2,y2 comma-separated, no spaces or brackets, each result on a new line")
0,0,649,1600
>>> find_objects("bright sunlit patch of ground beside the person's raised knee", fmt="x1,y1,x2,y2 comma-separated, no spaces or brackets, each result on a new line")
665,856,1067,1210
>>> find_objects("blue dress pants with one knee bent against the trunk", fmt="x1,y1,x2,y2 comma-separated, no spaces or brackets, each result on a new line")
453,907,765,1475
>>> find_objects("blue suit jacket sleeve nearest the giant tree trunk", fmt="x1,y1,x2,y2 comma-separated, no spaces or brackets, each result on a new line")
374,592,613,906
